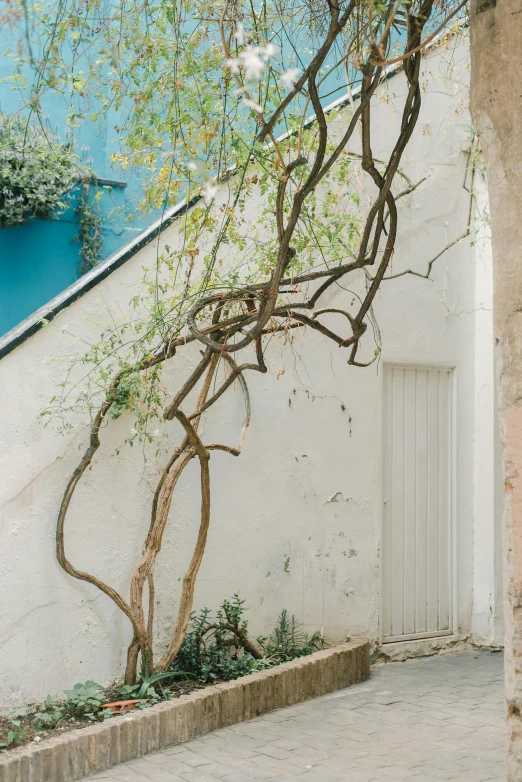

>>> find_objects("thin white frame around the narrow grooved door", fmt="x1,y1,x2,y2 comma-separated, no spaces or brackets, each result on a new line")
378,360,459,648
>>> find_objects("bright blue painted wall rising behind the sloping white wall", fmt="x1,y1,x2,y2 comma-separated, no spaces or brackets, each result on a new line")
0,15,362,336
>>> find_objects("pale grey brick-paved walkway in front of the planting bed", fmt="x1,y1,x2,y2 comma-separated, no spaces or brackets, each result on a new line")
89,652,505,782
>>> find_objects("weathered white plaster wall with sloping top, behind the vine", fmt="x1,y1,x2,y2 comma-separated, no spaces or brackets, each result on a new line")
0,38,498,702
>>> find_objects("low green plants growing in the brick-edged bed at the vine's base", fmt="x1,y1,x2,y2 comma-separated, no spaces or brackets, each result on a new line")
0,608,328,751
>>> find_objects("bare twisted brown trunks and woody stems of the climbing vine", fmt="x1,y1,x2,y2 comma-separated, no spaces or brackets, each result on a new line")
56,0,446,684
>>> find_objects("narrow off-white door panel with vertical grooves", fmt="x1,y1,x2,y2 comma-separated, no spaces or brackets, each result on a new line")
382,365,453,643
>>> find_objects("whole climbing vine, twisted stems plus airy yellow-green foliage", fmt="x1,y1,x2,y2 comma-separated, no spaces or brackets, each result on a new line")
27,0,464,685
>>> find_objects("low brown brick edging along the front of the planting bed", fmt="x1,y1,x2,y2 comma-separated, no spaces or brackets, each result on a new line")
0,639,370,782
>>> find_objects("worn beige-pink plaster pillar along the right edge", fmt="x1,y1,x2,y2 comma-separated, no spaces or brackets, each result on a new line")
471,0,522,782
